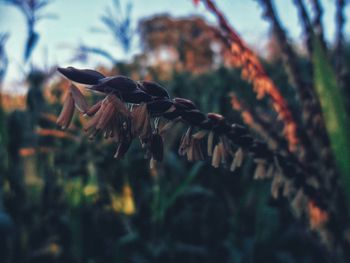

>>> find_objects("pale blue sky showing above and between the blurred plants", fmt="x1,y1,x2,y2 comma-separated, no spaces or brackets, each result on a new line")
0,0,350,92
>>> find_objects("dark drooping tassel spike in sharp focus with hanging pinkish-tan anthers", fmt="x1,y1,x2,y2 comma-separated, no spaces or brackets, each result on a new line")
57,67,326,224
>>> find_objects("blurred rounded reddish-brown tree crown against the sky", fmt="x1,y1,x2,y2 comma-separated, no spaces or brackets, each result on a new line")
139,15,229,73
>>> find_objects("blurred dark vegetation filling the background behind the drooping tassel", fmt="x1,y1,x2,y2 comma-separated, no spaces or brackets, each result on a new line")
0,0,350,262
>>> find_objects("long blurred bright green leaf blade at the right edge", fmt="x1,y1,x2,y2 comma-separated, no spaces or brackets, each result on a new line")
312,38,350,206
